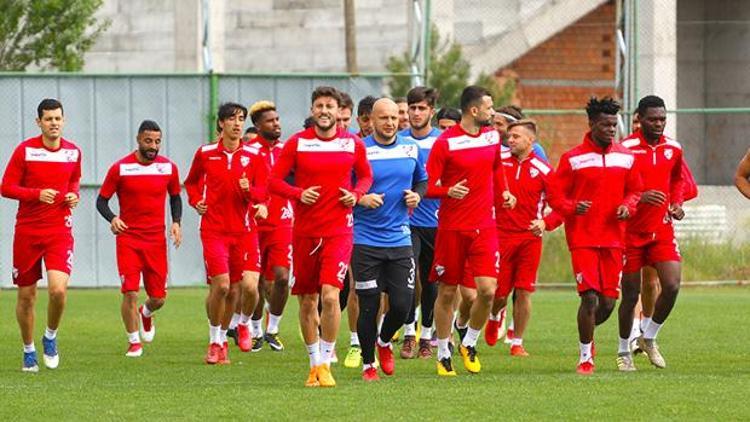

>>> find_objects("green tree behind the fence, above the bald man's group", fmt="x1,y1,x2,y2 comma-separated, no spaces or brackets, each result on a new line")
386,25,515,107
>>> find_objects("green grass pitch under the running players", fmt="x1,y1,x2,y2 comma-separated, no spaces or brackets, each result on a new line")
0,287,750,421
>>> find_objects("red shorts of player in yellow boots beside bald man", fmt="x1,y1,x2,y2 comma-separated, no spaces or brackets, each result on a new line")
430,227,500,288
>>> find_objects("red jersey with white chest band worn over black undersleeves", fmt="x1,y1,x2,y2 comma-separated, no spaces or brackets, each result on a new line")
99,152,180,237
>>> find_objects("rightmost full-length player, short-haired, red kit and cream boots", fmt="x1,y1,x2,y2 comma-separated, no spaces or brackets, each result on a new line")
617,95,685,371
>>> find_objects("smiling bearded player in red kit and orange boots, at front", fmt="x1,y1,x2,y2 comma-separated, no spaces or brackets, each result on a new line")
269,86,372,387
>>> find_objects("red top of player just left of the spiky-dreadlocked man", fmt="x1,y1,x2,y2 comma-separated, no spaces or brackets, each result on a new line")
495,152,562,239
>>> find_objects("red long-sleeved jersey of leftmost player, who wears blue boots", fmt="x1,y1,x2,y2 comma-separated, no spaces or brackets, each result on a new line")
2,135,81,234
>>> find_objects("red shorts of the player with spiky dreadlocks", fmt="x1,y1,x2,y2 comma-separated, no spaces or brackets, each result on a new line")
570,248,625,299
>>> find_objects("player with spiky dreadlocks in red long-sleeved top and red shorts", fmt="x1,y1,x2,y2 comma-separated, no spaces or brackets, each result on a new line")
548,97,641,375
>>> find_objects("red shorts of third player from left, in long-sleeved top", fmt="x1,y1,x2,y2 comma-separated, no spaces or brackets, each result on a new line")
201,232,260,284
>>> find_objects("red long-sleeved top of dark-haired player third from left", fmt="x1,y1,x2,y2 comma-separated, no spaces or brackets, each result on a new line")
185,139,268,233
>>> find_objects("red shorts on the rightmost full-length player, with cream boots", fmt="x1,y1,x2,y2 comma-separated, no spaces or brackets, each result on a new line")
624,225,682,274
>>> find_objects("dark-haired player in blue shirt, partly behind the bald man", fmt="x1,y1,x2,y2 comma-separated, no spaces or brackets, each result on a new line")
399,86,440,359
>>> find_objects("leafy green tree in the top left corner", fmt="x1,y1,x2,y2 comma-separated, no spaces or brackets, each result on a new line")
0,0,110,71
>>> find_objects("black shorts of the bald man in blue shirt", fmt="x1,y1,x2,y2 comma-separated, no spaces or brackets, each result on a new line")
352,245,415,295
